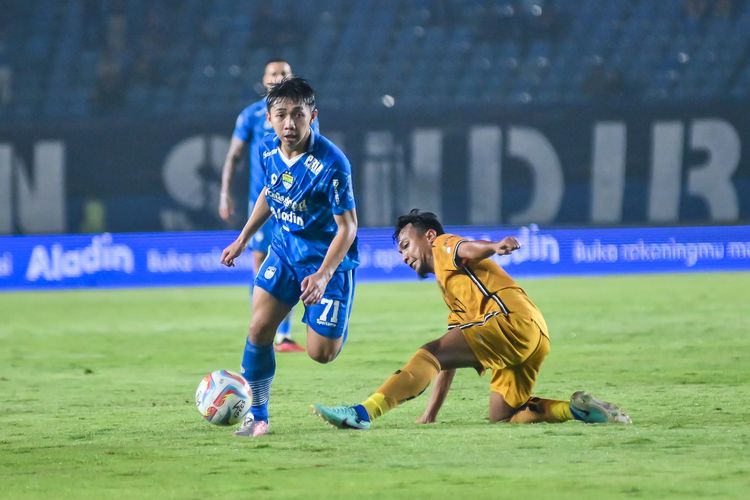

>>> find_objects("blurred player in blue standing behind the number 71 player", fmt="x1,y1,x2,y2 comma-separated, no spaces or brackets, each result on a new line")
219,59,318,352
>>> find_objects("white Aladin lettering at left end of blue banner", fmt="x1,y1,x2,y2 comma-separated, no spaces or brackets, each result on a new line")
26,233,135,281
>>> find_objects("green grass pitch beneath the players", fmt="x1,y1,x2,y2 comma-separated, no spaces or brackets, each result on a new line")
0,274,750,500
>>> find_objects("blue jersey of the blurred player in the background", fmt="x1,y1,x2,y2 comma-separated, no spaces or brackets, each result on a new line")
232,98,318,205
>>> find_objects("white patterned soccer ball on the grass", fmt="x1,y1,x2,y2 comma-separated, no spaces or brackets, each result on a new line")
195,370,252,425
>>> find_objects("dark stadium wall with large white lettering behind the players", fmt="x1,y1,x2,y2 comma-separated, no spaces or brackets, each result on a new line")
0,102,750,234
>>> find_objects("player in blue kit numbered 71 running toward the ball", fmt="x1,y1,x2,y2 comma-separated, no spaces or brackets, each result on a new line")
221,78,358,437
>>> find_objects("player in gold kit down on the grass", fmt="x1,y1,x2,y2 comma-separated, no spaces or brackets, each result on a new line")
313,209,630,429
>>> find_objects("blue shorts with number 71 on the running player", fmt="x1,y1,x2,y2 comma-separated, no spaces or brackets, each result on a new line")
255,249,355,341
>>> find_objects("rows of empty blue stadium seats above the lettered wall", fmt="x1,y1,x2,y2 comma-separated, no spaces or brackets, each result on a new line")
8,0,750,118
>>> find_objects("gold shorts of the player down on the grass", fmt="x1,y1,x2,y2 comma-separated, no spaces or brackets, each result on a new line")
462,310,550,408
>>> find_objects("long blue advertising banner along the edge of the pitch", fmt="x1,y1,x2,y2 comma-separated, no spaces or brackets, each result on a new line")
0,224,750,290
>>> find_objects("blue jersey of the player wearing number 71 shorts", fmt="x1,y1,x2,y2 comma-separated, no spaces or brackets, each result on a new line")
259,131,359,271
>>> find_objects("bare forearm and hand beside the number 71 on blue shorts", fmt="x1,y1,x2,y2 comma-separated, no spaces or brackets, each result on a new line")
300,209,357,306
